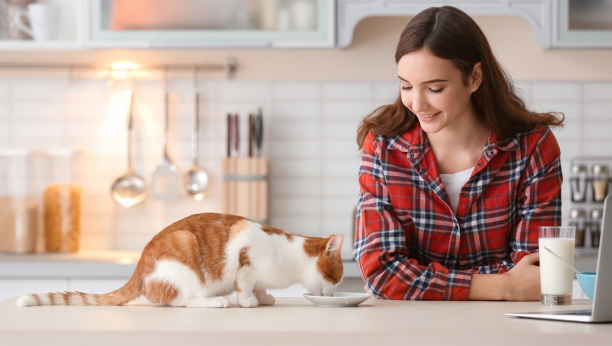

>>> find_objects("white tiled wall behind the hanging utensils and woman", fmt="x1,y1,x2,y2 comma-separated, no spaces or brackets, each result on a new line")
0,79,612,258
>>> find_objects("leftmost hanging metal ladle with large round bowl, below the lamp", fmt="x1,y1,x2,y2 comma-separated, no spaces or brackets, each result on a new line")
111,86,146,207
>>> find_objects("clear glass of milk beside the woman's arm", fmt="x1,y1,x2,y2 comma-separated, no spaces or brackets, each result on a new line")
538,226,576,305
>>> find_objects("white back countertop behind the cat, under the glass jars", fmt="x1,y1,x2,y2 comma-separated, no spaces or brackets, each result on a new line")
0,251,361,278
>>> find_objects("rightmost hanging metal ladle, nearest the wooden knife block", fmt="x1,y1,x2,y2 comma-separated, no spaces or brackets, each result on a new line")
185,69,208,201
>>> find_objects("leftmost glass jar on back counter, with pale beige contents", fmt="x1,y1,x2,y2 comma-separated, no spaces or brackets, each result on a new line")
0,149,40,253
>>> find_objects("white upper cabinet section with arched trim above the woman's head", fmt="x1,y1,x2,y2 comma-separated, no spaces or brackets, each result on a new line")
336,0,612,49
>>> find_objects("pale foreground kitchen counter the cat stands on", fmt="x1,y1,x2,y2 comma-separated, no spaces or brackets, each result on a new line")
0,297,612,346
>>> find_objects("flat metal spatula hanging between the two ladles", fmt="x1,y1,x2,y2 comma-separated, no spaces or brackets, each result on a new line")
151,68,179,201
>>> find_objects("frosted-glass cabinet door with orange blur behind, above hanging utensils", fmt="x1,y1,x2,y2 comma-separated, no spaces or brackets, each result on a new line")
86,0,335,48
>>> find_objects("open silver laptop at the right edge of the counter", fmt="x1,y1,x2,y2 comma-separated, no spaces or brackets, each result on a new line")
505,196,612,323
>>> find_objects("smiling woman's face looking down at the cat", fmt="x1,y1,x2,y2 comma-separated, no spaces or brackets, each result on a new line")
397,49,482,134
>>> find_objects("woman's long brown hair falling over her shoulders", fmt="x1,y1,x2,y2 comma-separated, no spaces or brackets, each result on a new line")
357,6,565,149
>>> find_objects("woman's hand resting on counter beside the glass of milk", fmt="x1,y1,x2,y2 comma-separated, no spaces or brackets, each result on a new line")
502,252,542,301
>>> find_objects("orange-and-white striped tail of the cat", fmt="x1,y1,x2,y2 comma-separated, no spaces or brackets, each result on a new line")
17,276,142,306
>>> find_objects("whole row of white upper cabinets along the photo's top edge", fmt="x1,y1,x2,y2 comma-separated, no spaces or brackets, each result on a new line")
0,0,612,50
